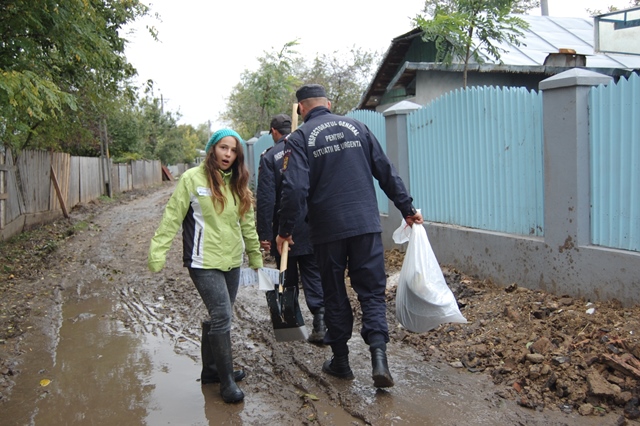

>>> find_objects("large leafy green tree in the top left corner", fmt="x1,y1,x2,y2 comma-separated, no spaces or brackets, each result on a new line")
0,0,148,150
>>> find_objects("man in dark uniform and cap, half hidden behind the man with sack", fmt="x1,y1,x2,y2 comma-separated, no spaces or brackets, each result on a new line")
256,114,326,344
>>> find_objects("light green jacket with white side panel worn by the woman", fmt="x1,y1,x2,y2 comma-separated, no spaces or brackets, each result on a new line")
148,164,262,272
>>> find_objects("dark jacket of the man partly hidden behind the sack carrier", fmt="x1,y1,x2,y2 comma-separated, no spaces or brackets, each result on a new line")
257,137,313,256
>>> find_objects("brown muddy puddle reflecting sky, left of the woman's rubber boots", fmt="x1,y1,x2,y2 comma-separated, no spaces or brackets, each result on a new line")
3,297,214,425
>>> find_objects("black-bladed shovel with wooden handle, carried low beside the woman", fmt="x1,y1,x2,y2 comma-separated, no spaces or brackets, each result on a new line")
266,241,309,342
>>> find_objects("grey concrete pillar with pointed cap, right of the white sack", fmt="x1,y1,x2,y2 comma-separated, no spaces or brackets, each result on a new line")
539,68,612,248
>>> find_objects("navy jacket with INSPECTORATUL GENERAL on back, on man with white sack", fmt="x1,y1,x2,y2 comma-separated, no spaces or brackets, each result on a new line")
278,107,413,244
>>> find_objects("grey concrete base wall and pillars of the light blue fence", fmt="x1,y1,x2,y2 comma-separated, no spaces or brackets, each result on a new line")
370,69,640,305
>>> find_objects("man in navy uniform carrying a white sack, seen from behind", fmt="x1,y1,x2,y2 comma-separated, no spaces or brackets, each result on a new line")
276,84,423,387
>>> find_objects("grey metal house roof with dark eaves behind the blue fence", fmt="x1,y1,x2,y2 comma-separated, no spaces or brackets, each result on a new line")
358,15,640,109
